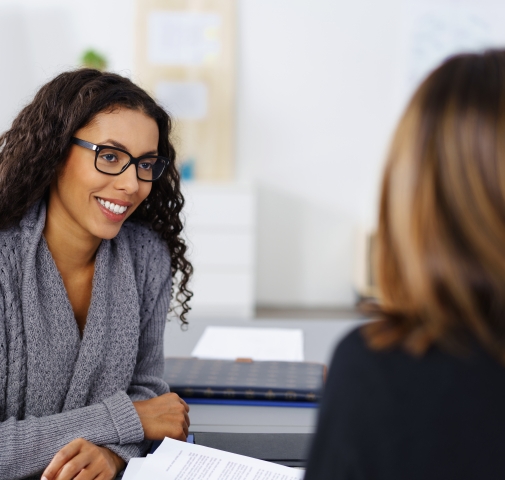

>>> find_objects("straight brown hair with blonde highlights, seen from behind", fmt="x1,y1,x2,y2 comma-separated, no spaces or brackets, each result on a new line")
365,50,505,362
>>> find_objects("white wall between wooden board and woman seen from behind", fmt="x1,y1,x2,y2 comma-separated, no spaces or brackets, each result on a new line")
237,0,406,306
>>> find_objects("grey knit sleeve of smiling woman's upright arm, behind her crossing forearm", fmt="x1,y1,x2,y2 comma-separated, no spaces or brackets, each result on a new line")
105,231,171,461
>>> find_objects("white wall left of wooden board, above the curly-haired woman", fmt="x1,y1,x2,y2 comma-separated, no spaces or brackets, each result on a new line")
0,0,134,131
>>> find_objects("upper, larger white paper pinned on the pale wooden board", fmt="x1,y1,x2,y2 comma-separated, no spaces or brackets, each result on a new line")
147,11,221,66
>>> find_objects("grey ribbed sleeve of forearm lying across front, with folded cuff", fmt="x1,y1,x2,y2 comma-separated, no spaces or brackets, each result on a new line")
0,392,144,479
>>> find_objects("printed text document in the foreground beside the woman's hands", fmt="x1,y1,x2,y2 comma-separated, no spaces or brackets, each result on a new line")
129,438,304,480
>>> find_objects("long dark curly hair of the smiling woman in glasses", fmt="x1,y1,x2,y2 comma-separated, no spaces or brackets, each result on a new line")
0,68,193,324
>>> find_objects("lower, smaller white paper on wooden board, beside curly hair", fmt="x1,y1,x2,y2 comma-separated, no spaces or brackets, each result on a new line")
156,82,209,120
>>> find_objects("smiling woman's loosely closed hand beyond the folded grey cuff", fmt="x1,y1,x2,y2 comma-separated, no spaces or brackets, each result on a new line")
133,393,189,441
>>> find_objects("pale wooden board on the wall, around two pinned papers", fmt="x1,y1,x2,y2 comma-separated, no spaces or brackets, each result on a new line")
135,0,236,180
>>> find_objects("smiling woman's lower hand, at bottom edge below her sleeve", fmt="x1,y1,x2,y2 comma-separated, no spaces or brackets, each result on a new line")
42,438,125,480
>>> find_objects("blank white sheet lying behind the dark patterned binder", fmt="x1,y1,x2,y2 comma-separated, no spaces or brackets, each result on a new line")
191,327,303,362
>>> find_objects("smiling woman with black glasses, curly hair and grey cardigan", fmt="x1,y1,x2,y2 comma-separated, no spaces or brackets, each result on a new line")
0,69,192,480
